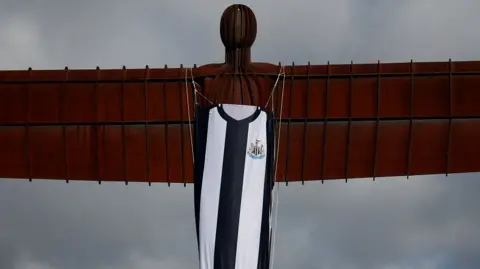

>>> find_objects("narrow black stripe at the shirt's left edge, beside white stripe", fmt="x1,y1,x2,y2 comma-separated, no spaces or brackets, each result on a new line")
193,107,210,248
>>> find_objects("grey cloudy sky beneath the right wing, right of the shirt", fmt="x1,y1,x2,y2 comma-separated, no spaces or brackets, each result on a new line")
277,173,480,268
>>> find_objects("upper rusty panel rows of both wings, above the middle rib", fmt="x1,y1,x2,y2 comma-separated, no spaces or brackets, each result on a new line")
0,62,480,122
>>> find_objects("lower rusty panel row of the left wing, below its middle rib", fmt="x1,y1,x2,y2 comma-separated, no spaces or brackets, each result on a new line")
0,125,192,182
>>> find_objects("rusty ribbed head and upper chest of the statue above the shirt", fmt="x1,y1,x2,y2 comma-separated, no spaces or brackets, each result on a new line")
201,5,275,106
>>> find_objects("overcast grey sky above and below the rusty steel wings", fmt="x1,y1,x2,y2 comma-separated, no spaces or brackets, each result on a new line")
0,0,480,269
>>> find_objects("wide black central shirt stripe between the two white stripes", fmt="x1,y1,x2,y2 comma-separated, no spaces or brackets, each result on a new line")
214,121,249,269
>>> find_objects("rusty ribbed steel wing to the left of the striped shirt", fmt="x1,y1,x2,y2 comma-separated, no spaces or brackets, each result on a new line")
0,68,193,183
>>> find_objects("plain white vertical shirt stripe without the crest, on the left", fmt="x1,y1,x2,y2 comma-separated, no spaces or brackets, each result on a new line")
199,108,227,269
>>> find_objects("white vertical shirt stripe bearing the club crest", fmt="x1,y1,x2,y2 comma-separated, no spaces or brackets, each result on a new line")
235,111,270,269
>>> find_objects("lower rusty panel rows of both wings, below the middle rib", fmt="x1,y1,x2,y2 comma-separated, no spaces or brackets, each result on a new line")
0,119,480,183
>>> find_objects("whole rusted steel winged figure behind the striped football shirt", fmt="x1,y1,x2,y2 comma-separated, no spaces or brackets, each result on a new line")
0,5,480,183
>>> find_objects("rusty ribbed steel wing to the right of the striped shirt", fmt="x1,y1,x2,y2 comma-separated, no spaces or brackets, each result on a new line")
275,62,480,181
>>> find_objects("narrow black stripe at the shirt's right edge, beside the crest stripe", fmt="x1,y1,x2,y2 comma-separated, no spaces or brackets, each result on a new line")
257,113,275,269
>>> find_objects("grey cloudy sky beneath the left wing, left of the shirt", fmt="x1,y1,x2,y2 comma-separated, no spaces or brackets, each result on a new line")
0,181,196,268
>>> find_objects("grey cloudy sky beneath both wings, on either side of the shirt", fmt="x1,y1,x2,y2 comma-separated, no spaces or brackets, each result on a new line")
0,175,480,269
